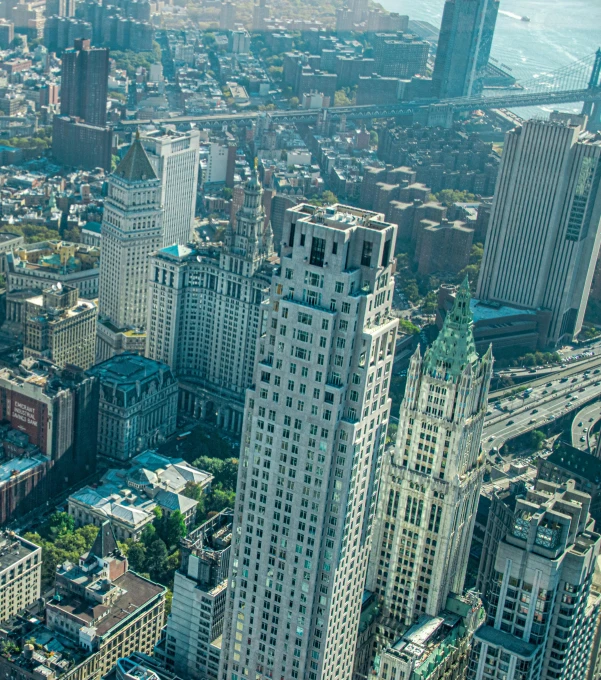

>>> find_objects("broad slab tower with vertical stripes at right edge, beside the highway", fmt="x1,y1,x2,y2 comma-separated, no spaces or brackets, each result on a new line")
476,121,601,347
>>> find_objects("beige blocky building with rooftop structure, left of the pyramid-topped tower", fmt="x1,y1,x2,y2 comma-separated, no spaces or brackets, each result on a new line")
23,284,97,370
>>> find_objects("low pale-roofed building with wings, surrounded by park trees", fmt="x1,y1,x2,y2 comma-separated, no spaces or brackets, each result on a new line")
68,451,213,541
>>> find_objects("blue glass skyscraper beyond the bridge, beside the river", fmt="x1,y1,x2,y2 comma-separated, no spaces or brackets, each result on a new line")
432,0,499,99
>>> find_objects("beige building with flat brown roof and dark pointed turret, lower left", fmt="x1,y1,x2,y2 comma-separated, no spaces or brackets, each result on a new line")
0,522,166,680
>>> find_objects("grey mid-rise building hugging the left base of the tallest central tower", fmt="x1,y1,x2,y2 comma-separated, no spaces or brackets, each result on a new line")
155,510,234,680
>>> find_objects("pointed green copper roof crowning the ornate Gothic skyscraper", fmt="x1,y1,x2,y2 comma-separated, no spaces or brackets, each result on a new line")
424,277,478,378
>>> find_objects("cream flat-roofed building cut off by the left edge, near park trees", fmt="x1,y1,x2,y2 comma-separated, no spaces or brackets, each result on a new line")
0,531,42,621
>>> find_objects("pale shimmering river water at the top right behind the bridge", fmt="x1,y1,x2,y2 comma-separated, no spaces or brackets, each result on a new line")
379,0,601,117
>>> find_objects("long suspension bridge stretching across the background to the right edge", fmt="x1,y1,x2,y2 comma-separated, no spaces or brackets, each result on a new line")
117,48,601,129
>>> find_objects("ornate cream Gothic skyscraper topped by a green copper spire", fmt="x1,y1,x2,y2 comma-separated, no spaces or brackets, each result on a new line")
358,280,492,660
